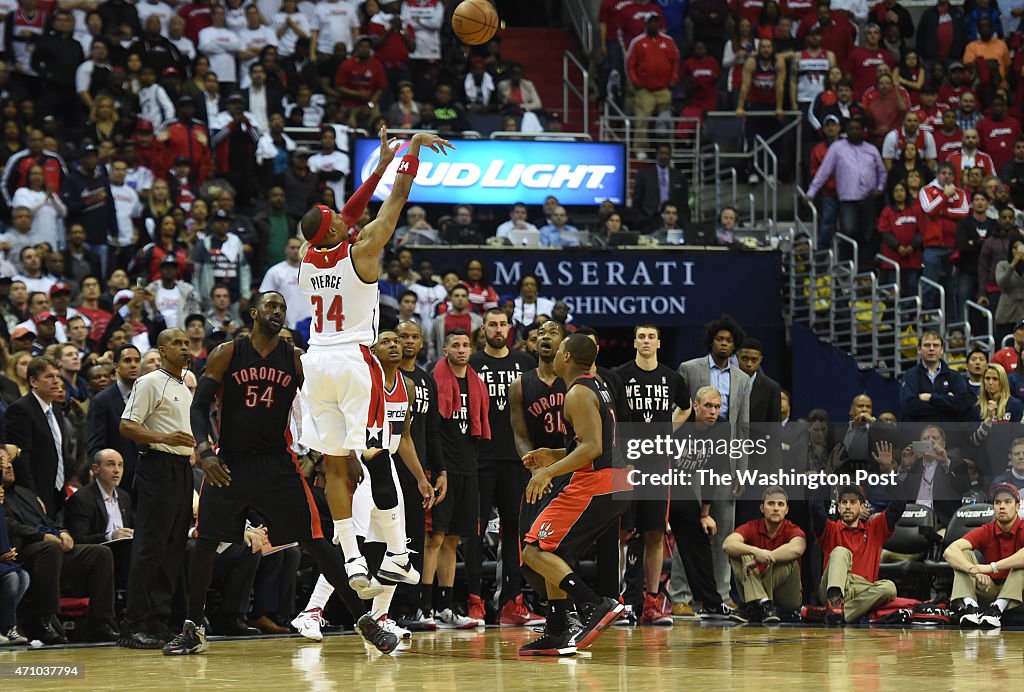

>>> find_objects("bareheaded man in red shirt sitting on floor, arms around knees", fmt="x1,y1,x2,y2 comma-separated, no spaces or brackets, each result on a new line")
722,485,807,624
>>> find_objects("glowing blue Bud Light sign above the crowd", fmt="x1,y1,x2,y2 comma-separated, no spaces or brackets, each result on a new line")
355,139,626,205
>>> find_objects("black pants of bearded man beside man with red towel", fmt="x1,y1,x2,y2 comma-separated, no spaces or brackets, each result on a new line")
463,459,529,609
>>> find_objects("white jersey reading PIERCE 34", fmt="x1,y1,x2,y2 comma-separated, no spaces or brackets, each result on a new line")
299,241,380,346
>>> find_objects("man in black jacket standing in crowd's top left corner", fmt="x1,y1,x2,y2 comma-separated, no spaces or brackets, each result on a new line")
32,9,85,130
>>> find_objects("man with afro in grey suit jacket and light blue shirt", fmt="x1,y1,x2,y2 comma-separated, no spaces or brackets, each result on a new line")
673,315,751,603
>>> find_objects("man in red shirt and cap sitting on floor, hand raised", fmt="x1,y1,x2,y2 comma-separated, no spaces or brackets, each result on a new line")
811,442,906,624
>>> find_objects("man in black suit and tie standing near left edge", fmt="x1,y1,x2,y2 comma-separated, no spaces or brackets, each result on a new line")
6,356,76,519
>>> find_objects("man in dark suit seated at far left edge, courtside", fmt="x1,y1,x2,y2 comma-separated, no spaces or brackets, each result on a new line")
0,448,118,644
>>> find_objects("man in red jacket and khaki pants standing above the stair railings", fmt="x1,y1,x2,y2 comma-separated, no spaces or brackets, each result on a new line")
626,12,679,155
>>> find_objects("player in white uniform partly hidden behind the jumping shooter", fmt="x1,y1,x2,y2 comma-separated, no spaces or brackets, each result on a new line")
292,332,434,651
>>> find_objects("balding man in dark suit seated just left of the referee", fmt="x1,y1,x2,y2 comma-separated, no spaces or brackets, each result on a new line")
65,448,135,588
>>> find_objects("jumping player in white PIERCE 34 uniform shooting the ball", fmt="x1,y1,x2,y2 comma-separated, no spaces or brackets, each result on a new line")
299,127,455,596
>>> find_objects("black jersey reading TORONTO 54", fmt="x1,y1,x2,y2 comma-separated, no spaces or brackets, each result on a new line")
220,338,299,452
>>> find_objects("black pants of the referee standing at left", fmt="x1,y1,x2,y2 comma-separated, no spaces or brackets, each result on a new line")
124,450,195,633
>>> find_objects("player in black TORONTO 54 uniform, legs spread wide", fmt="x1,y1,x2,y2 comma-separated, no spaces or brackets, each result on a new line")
164,291,397,655
